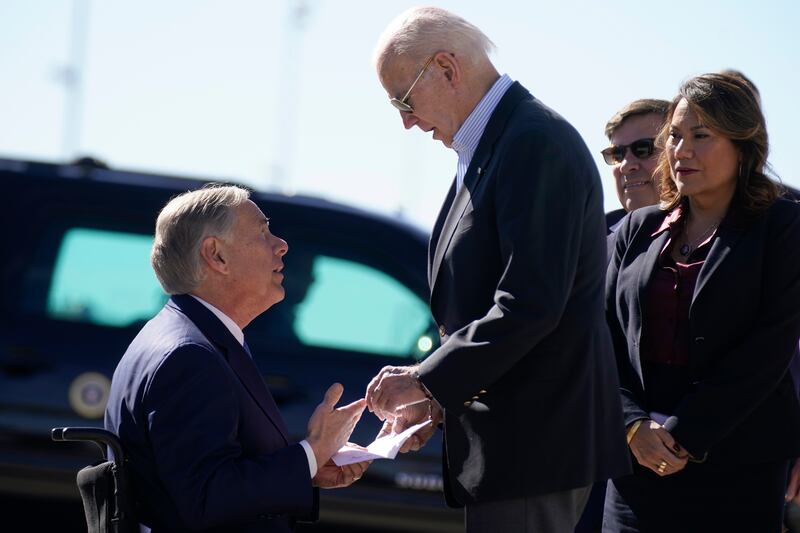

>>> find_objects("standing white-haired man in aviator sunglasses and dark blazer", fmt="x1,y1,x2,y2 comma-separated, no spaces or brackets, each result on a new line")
366,8,630,533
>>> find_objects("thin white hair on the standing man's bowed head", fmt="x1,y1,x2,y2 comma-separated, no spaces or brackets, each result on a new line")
372,7,495,71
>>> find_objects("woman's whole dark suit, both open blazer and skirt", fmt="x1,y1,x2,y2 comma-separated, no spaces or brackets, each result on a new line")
604,199,800,532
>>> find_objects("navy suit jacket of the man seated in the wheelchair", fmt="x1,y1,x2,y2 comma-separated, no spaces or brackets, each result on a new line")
105,295,317,532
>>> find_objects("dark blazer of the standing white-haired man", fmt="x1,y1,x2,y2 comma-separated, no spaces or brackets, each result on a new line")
419,83,630,505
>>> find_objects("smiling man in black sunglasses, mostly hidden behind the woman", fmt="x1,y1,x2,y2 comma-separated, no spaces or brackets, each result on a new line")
601,99,669,233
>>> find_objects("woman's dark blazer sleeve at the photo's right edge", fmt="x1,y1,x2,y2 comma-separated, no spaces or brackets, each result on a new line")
672,210,800,457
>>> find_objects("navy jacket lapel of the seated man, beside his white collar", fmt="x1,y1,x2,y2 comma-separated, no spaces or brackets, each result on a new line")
171,295,289,445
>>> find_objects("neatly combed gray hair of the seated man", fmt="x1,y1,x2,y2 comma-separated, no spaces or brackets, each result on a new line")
150,183,250,294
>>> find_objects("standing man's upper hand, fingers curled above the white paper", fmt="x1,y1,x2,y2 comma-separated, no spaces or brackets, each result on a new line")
366,366,426,420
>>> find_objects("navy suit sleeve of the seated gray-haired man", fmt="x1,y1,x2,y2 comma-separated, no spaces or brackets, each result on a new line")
144,344,315,529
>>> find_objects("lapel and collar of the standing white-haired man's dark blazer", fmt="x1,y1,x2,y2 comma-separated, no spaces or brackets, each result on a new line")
428,82,532,302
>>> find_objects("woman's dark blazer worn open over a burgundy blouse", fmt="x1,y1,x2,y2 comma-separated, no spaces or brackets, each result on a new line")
606,199,800,464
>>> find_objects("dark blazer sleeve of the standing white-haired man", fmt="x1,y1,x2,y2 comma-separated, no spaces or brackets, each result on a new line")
419,131,592,408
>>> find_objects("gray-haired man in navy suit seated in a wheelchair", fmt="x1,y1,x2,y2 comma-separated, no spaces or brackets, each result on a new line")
105,186,367,532
